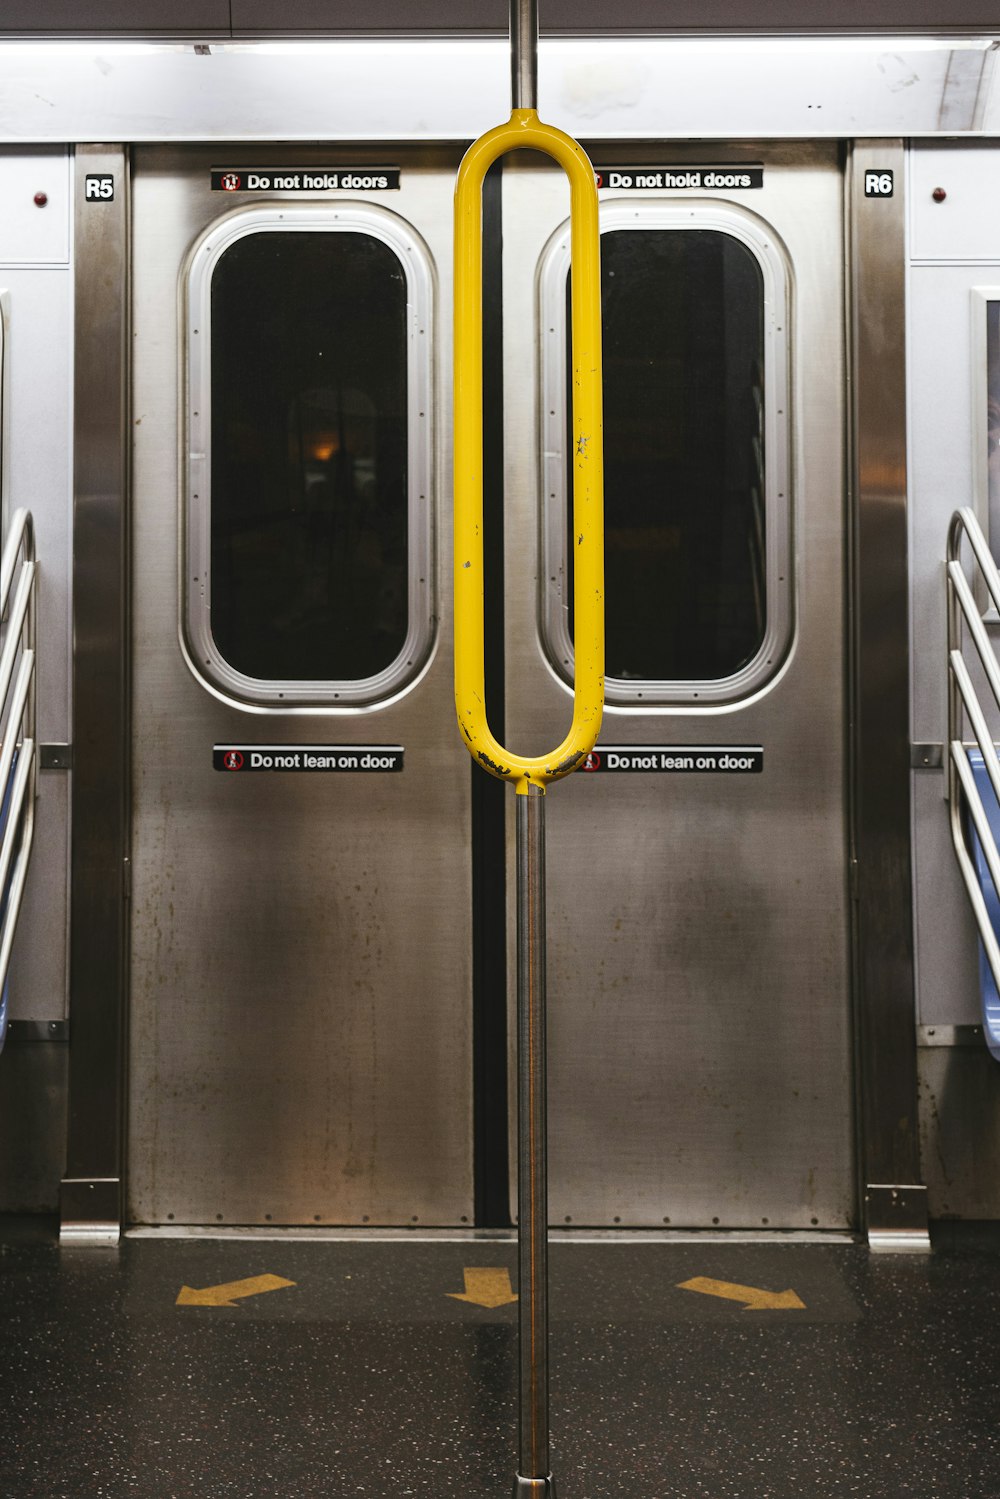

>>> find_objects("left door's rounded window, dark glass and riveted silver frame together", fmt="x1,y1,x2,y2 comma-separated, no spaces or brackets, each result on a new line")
184,205,432,708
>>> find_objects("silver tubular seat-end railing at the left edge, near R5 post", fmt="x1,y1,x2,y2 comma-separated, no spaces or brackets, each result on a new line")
0,510,37,1048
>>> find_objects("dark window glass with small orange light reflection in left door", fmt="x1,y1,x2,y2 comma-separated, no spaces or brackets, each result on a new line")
211,231,408,682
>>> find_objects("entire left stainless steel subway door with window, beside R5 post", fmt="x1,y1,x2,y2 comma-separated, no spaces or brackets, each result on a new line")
127,147,472,1226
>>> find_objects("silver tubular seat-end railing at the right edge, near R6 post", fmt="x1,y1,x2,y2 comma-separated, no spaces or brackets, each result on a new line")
946,505,1000,1061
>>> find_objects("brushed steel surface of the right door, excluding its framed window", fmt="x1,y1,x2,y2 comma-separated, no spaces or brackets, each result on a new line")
504,144,856,1229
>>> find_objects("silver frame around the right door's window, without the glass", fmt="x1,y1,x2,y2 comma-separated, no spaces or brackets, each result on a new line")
538,201,793,708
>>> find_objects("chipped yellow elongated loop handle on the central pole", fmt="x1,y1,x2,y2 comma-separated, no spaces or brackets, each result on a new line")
454,109,604,794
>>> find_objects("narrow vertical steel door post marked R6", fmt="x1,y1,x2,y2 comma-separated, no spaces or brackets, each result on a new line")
849,141,927,1241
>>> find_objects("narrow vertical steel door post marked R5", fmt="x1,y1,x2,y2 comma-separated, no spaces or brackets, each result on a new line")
63,147,129,1237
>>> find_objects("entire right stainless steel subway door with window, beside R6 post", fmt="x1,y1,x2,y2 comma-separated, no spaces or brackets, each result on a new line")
504,142,856,1231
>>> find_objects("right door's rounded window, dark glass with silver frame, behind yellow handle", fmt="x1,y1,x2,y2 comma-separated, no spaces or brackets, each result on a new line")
543,204,790,703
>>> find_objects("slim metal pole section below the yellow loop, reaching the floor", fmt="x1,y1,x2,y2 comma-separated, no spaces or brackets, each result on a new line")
514,785,555,1499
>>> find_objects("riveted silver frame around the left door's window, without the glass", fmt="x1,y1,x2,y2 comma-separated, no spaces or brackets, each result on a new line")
180,201,435,712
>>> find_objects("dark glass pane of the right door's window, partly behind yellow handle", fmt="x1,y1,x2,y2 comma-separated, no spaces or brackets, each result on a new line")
567,229,766,682
